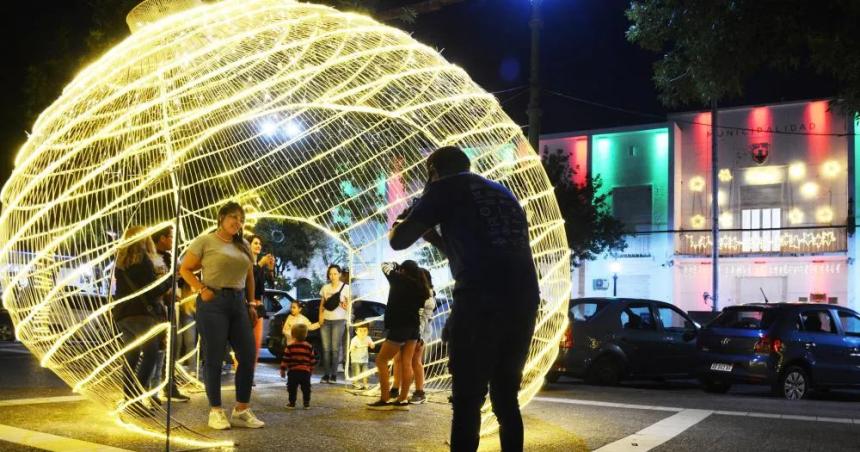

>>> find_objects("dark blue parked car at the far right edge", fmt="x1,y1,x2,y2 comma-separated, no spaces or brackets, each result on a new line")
697,303,860,400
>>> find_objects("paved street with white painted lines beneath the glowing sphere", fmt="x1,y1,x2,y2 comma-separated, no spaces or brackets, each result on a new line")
0,343,860,452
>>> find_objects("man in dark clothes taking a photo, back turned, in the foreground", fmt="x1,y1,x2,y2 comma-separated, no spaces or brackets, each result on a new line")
388,147,540,452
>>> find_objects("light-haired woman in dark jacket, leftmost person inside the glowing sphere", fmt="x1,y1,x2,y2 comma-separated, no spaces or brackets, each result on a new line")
113,226,171,412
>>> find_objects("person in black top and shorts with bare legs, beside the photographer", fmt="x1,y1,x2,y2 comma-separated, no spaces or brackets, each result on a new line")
367,260,430,410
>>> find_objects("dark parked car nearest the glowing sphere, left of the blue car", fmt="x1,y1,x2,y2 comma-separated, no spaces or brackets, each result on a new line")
547,298,698,385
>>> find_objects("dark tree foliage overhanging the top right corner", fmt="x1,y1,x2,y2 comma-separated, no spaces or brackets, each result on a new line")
627,0,860,111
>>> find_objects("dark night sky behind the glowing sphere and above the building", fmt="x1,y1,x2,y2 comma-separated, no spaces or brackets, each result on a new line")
0,0,835,187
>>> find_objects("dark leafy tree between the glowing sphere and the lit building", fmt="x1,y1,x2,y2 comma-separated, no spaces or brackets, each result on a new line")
543,149,627,262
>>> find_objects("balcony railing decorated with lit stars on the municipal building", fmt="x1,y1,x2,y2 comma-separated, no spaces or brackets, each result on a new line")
675,227,848,256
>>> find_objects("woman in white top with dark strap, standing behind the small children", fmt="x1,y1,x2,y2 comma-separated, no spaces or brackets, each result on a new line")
319,264,350,383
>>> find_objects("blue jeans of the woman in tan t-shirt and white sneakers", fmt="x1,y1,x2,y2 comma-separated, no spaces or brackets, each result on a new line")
192,289,256,407
